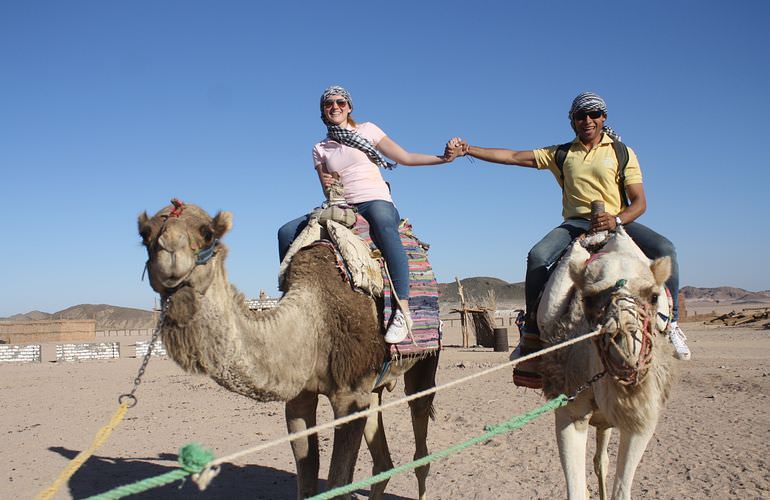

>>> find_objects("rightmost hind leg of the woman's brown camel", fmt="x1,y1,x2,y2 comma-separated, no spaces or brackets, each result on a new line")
404,355,438,500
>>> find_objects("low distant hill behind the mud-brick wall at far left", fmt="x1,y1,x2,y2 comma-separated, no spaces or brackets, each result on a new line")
0,304,156,330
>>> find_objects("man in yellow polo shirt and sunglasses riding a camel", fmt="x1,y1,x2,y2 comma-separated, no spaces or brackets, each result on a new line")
450,92,690,388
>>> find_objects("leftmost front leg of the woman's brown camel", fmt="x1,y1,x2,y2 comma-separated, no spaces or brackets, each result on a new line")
285,392,319,498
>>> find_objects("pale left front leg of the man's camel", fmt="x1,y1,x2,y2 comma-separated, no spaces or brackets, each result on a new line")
556,401,589,500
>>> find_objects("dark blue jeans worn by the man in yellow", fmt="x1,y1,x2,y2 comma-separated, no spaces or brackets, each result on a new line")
524,219,679,333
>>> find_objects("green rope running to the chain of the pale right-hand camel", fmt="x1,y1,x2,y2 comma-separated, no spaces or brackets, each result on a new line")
308,394,569,500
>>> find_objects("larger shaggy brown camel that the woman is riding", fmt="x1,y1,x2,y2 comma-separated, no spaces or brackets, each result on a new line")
139,201,438,499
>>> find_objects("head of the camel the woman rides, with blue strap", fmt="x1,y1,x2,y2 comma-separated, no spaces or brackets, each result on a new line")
139,199,232,297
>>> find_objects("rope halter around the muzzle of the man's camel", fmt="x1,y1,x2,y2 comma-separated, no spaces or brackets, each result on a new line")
595,279,654,387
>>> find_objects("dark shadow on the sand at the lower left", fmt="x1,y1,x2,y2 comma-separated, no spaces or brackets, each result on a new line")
48,446,406,500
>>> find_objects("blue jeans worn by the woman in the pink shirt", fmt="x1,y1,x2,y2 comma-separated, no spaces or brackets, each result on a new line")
278,200,409,300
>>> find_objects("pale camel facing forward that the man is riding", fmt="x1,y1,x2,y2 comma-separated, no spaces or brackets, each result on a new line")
538,228,672,499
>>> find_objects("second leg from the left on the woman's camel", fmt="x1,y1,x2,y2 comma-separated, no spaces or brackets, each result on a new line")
326,392,370,498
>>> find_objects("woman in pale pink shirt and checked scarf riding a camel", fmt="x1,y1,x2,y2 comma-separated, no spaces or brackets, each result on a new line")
278,85,458,344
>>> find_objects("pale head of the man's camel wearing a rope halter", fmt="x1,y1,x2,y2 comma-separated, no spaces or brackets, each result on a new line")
570,252,671,385
